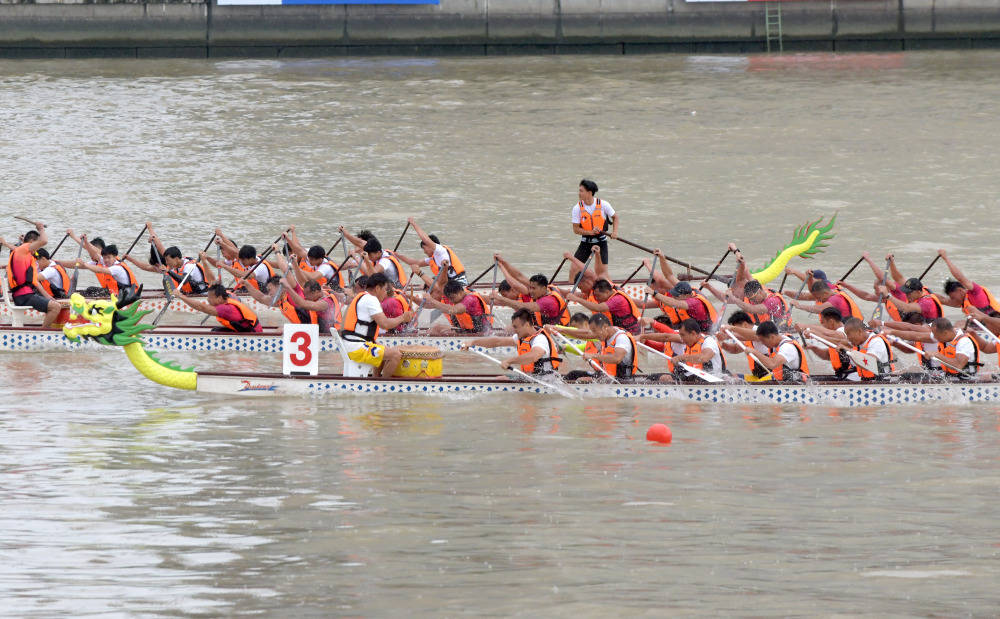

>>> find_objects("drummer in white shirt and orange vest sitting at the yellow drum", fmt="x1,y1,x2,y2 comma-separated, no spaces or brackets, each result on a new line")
340,273,413,378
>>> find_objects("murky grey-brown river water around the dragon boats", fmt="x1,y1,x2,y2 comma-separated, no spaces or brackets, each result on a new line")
0,52,1000,617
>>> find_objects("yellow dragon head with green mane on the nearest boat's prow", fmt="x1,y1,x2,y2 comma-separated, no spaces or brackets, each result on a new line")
63,286,153,346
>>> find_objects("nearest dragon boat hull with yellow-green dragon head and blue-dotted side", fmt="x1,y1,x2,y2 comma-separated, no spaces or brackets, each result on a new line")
56,295,1000,407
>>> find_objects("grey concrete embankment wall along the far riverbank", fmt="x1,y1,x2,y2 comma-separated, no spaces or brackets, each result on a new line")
0,0,1000,58
